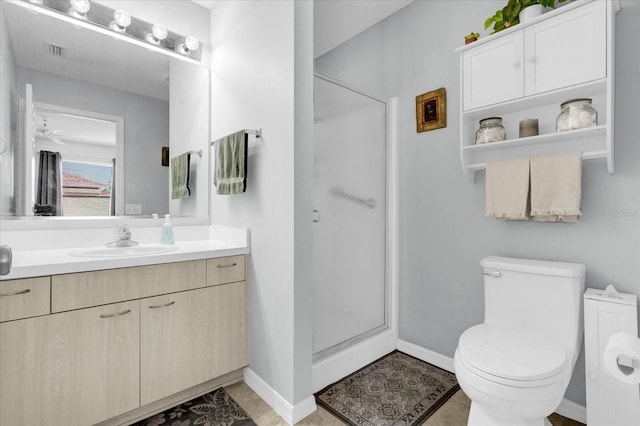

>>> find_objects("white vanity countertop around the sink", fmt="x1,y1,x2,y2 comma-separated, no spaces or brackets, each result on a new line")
0,240,249,280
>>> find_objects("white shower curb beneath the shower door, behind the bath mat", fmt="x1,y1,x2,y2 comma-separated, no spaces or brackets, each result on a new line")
312,330,397,392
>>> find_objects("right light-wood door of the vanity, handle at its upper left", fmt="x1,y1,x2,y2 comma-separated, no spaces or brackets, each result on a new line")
140,282,246,404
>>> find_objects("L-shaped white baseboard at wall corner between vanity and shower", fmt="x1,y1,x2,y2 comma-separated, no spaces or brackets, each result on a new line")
243,367,316,425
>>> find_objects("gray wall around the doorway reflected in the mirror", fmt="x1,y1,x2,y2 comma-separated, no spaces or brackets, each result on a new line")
18,67,169,215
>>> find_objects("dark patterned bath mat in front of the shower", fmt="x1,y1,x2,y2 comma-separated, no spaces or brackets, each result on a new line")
315,351,459,426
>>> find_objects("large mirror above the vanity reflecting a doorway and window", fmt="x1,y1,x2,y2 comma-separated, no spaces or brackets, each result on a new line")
0,0,209,223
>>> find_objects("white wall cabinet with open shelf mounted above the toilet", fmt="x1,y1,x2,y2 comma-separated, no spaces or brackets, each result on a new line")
457,0,619,179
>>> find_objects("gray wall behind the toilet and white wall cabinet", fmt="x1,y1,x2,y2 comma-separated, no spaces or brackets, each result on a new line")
316,0,640,405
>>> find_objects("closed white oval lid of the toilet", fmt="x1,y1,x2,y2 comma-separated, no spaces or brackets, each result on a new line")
458,324,566,380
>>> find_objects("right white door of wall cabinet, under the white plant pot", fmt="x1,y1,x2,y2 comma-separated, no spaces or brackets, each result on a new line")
525,1,607,95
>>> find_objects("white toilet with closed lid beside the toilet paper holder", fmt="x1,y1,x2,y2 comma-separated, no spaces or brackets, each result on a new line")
453,256,585,426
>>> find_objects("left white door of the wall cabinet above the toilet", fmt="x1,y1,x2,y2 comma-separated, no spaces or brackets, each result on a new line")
462,32,524,111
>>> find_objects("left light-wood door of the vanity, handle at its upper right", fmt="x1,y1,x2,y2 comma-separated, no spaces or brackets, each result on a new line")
0,301,140,426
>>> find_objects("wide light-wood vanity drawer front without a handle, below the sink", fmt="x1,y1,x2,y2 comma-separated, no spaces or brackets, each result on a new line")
51,260,207,312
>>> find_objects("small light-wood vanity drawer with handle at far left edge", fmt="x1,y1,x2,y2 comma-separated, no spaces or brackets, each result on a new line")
0,277,51,322
